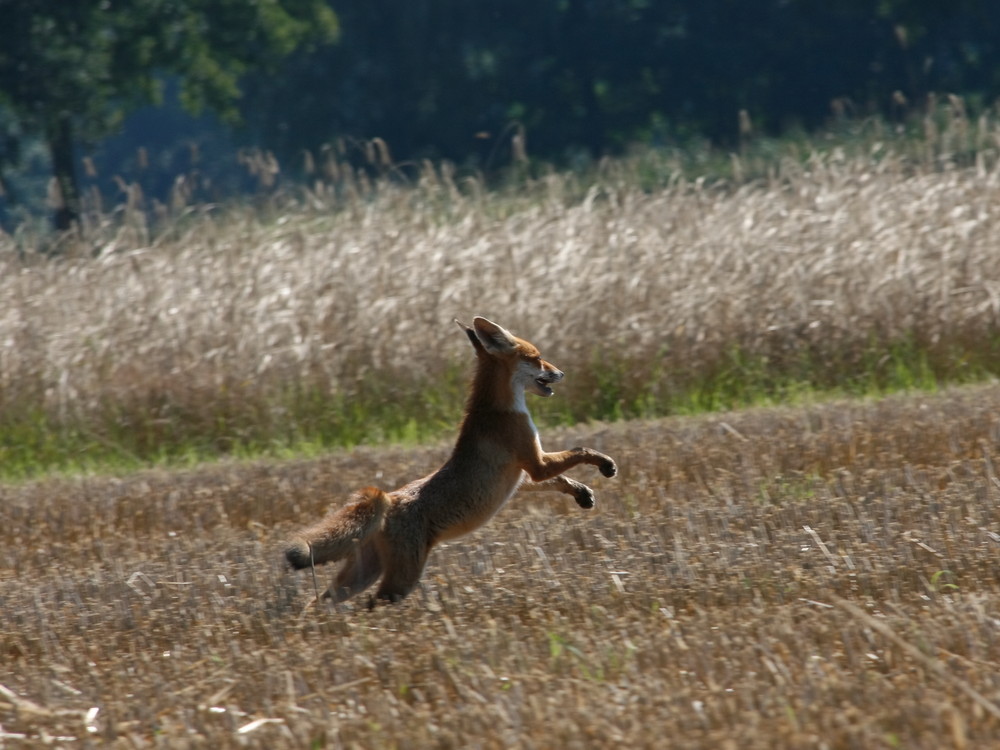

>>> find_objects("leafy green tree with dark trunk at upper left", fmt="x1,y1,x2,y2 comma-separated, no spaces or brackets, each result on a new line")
0,0,338,228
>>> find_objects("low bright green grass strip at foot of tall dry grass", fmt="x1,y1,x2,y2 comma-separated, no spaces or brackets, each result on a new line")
0,329,988,480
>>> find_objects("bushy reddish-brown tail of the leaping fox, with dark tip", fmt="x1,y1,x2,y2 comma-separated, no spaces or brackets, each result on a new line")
285,487,390,570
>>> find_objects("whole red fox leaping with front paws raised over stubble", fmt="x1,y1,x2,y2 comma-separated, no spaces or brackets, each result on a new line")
285,317,618,604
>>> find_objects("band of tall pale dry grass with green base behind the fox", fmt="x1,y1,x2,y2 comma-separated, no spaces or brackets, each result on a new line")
0,111,1000,473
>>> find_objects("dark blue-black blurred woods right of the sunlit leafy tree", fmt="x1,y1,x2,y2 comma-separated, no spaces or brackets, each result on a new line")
243,0,1000,167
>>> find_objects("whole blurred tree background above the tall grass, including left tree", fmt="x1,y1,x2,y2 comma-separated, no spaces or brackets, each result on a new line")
0,0,1000,228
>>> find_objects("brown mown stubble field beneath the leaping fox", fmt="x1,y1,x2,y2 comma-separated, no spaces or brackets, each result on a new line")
0,384,1000,749
